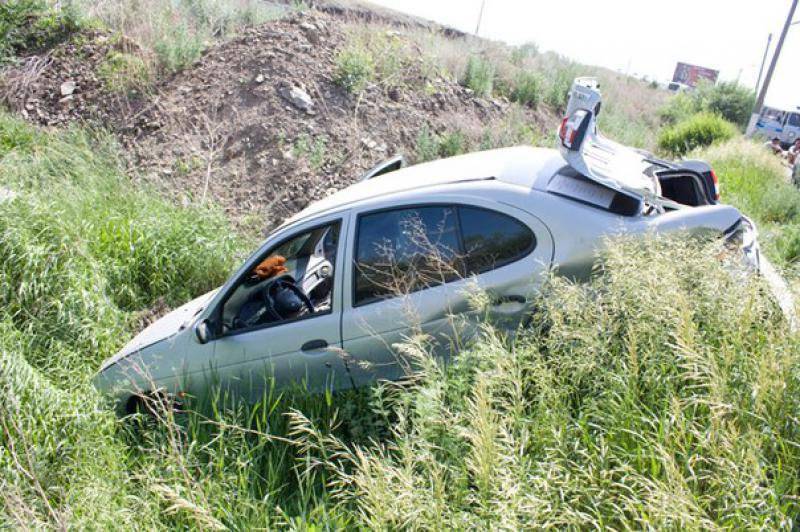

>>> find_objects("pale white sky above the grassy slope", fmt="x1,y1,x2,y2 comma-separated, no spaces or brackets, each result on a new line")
371,0,800,109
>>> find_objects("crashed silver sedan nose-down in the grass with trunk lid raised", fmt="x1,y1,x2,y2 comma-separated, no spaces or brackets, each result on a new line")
95,78,792,411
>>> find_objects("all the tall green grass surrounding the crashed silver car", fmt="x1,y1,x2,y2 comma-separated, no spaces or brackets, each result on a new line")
0,115,800,530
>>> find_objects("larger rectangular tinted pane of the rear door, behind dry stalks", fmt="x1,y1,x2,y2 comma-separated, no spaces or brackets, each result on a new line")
353,206,463,306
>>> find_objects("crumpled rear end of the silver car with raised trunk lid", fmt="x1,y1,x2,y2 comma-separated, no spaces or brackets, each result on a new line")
560,78,798,330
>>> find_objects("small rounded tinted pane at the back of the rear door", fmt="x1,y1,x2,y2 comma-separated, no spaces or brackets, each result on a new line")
458,207,536,274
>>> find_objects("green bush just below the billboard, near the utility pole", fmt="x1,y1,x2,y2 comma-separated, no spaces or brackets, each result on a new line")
659,81,755,129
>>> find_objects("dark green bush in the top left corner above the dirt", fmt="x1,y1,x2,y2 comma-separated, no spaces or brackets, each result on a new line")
0,0,80,62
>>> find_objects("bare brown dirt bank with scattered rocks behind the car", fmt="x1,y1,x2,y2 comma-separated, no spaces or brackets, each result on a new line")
5,10,545,230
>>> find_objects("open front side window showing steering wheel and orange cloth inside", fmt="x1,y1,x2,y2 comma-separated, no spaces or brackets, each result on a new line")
222,223,339,334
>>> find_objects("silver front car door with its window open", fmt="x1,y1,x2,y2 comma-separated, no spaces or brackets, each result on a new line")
206,215,350,399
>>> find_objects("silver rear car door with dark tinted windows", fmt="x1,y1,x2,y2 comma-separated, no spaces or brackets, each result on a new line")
342,200,552,385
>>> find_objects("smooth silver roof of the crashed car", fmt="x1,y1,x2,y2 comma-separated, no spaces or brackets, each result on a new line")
283,146,567,226
